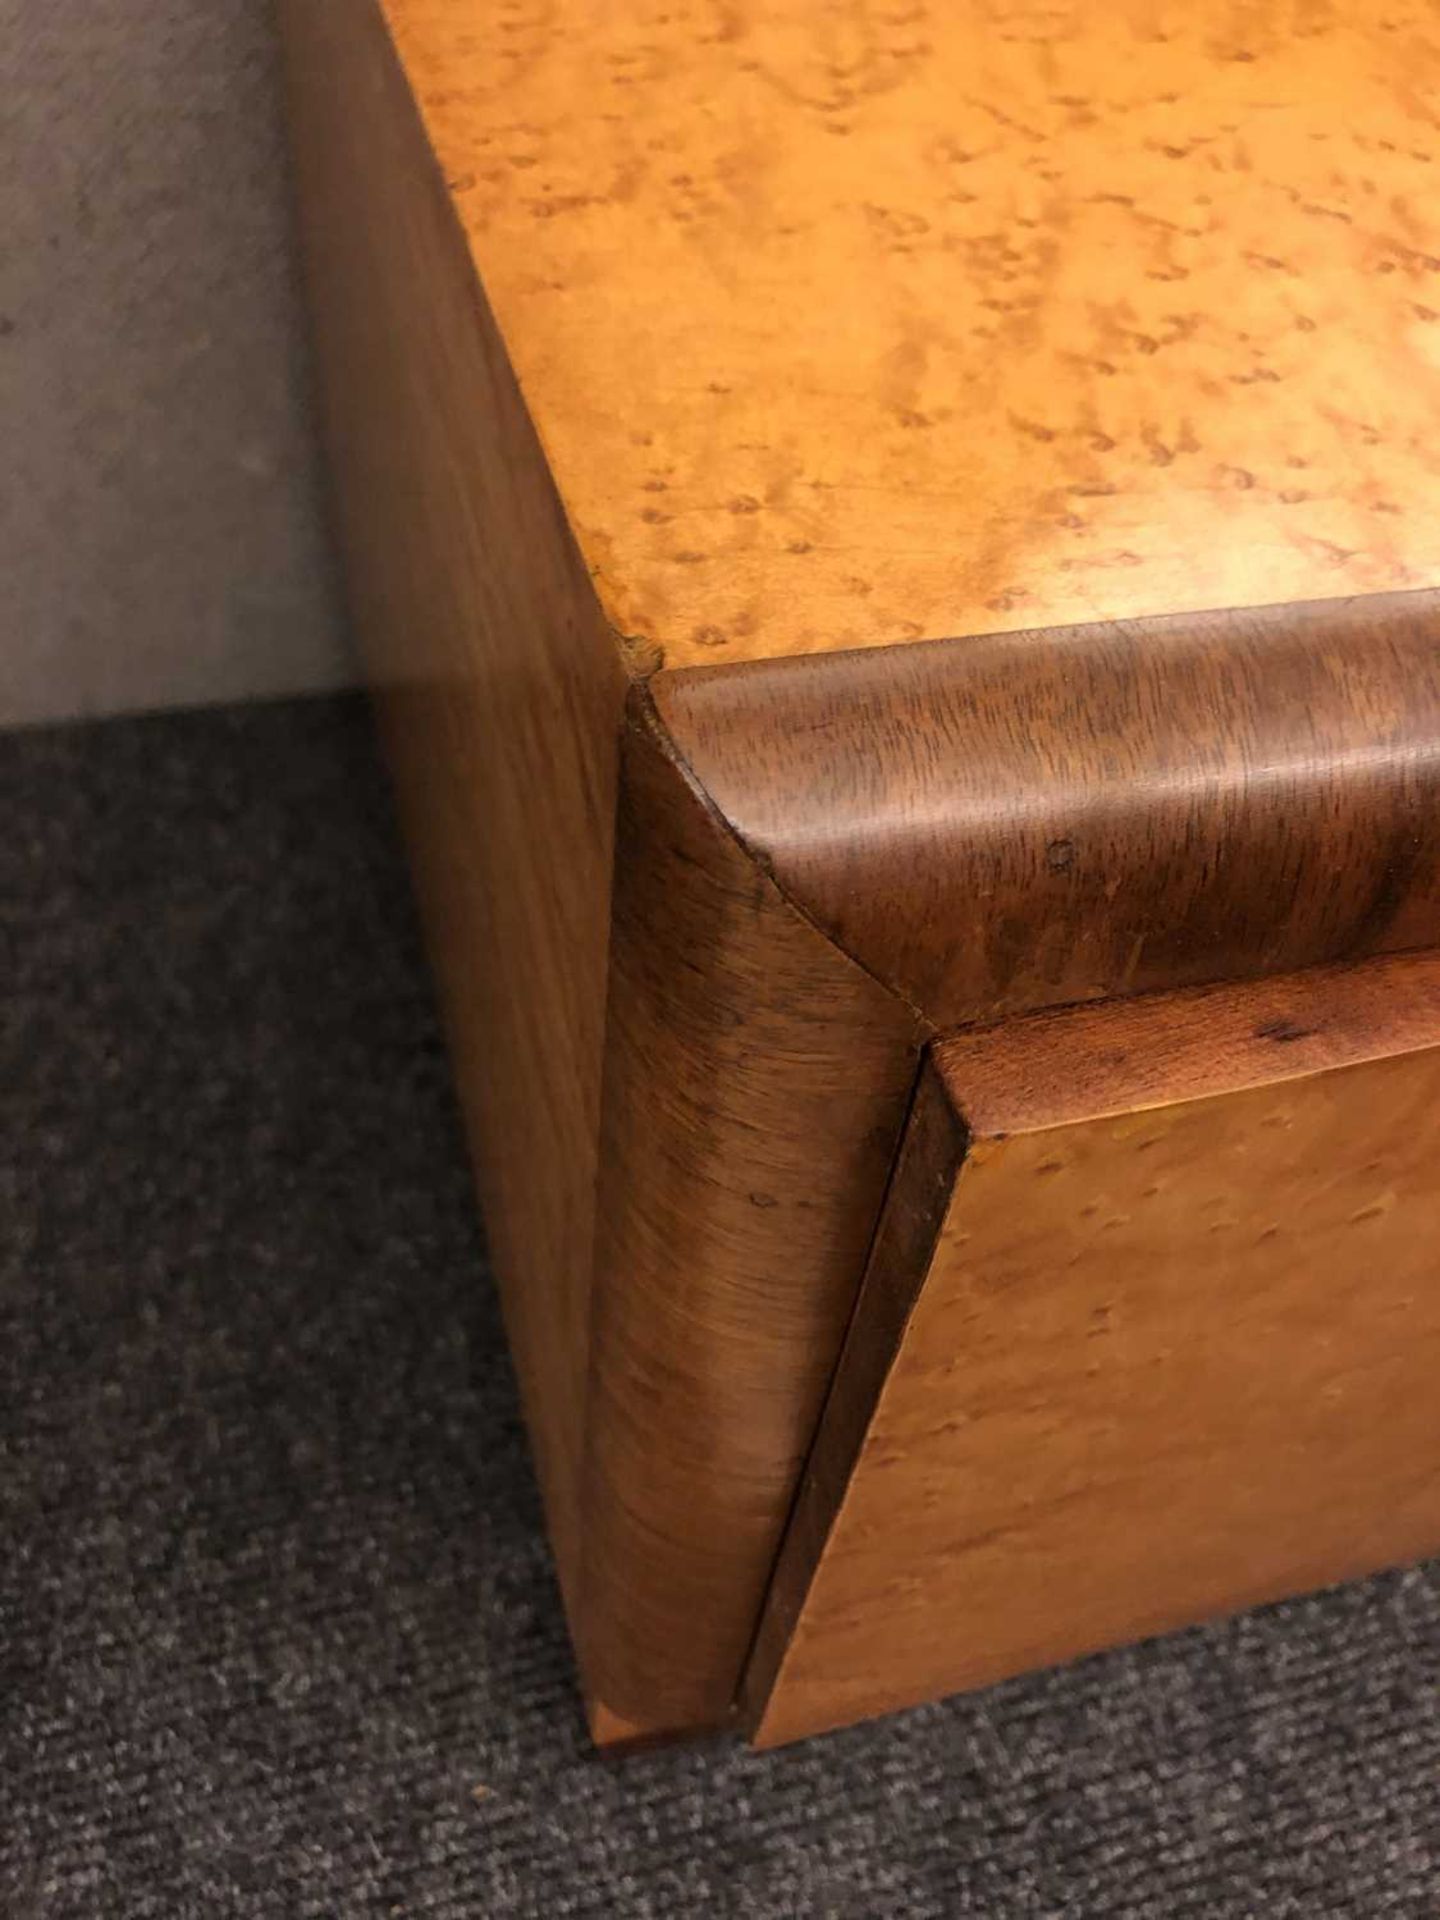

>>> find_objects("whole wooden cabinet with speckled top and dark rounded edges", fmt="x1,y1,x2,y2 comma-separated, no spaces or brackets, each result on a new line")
280,0,1440,1743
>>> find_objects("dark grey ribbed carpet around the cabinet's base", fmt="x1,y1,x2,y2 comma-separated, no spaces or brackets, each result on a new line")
0,697,1440,1920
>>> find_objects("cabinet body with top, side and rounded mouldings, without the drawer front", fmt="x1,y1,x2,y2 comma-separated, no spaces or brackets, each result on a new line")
280,0,1440,1743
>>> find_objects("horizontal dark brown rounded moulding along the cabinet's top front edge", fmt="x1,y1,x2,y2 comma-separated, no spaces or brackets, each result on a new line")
653,593,1440,1031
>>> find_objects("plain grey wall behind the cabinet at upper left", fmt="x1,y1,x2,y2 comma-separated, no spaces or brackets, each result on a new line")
0,0,349,726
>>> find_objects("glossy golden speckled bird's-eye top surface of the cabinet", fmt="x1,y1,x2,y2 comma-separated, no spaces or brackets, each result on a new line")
384,0,1440,664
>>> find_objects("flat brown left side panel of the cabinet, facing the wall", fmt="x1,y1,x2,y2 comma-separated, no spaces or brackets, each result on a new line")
282,0,626,1611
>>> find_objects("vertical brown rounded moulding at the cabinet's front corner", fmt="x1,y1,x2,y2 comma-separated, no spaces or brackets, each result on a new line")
580,691,920,1732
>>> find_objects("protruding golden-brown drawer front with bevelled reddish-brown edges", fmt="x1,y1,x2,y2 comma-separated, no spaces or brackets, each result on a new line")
753,954,1440,1745
